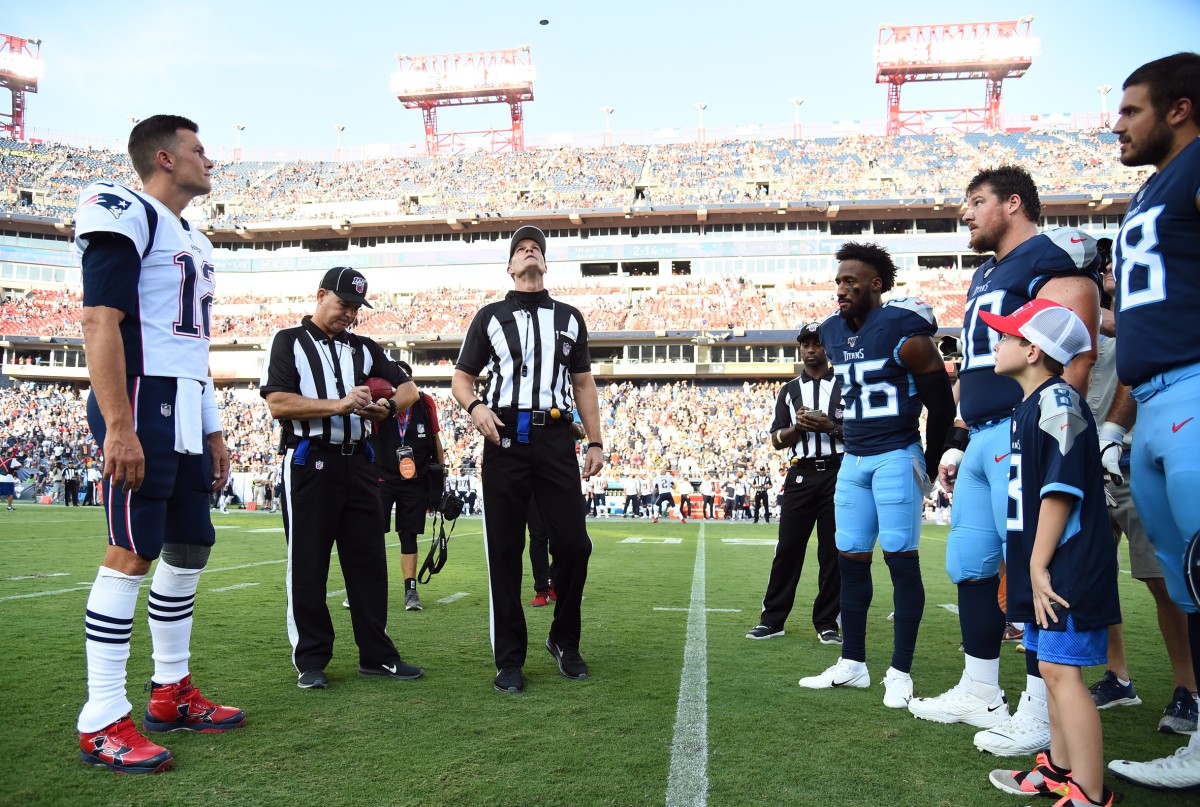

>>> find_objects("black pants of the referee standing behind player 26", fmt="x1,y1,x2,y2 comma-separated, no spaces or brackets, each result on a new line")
758,461,841,633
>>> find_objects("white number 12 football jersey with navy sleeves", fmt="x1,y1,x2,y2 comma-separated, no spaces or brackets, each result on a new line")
76,181,215,381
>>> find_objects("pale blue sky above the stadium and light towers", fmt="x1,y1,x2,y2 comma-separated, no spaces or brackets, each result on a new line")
9,0,1200,150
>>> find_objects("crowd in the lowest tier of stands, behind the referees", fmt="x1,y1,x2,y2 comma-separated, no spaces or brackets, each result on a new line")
0,382,780,504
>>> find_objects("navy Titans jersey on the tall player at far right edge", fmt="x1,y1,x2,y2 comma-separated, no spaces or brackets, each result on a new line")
1112,139,1200,387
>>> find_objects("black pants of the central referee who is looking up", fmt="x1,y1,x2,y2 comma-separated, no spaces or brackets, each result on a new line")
481,425,592,669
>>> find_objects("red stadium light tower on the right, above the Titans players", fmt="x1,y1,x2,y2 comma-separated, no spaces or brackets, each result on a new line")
875,17,1040,135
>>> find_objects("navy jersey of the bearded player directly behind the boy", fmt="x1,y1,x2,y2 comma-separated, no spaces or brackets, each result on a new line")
959,227,1103,426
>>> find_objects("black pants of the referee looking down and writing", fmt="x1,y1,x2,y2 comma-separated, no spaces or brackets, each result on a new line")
283,446,400,673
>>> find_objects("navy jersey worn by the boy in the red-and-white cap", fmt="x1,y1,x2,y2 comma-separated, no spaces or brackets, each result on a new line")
1004,377,1121,630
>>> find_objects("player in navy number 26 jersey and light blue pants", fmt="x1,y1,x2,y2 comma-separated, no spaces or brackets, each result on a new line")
799,243,954,709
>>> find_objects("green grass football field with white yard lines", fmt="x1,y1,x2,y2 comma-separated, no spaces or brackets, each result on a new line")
0,504,1195,807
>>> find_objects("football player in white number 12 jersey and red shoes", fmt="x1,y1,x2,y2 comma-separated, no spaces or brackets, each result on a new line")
76,115,246,773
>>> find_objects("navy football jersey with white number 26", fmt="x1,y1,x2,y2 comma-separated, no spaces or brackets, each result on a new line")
821,298,937,456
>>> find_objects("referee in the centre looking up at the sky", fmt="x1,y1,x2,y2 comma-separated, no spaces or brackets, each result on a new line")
451,226,604,692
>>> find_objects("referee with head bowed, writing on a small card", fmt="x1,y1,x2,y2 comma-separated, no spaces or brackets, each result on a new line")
259,267,425,689
